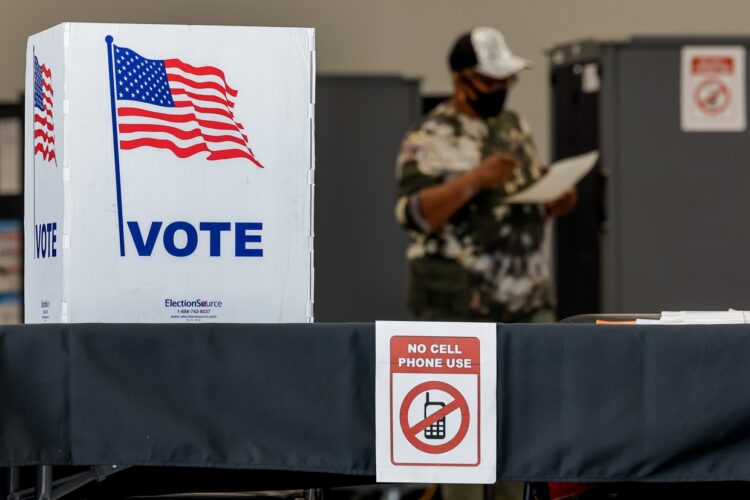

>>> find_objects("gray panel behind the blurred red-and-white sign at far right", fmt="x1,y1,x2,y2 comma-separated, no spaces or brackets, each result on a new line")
605,43,750,312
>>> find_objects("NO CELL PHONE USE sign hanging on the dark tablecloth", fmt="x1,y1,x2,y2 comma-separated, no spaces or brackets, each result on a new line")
375,321,497,483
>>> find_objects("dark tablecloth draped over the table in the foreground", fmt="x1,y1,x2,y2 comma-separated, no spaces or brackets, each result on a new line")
0,323,750,498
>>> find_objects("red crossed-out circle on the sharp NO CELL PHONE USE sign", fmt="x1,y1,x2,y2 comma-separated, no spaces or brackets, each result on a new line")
399,380,469,454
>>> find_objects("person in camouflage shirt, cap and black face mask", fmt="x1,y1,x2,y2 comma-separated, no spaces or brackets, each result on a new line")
396,28,576,322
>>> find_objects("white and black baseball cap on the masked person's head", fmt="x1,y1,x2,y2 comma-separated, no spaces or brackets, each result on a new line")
448,27,532,79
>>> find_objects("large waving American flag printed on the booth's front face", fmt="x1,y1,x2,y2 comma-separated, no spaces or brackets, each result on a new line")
112,45,263,168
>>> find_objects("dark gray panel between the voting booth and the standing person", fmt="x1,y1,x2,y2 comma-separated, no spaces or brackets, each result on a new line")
314,76,420,321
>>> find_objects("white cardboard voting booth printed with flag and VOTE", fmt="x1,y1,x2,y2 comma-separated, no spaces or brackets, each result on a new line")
24,23,315,323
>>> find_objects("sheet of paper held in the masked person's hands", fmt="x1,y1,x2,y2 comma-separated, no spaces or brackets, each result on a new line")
505,151,599,203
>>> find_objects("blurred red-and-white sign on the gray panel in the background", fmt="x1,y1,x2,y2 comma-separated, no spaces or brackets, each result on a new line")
680,46,747,132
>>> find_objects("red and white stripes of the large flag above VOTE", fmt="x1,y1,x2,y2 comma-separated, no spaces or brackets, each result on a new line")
117,59,263,168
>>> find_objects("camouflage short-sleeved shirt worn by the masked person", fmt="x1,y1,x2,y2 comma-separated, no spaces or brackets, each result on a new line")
396,101,553,322
